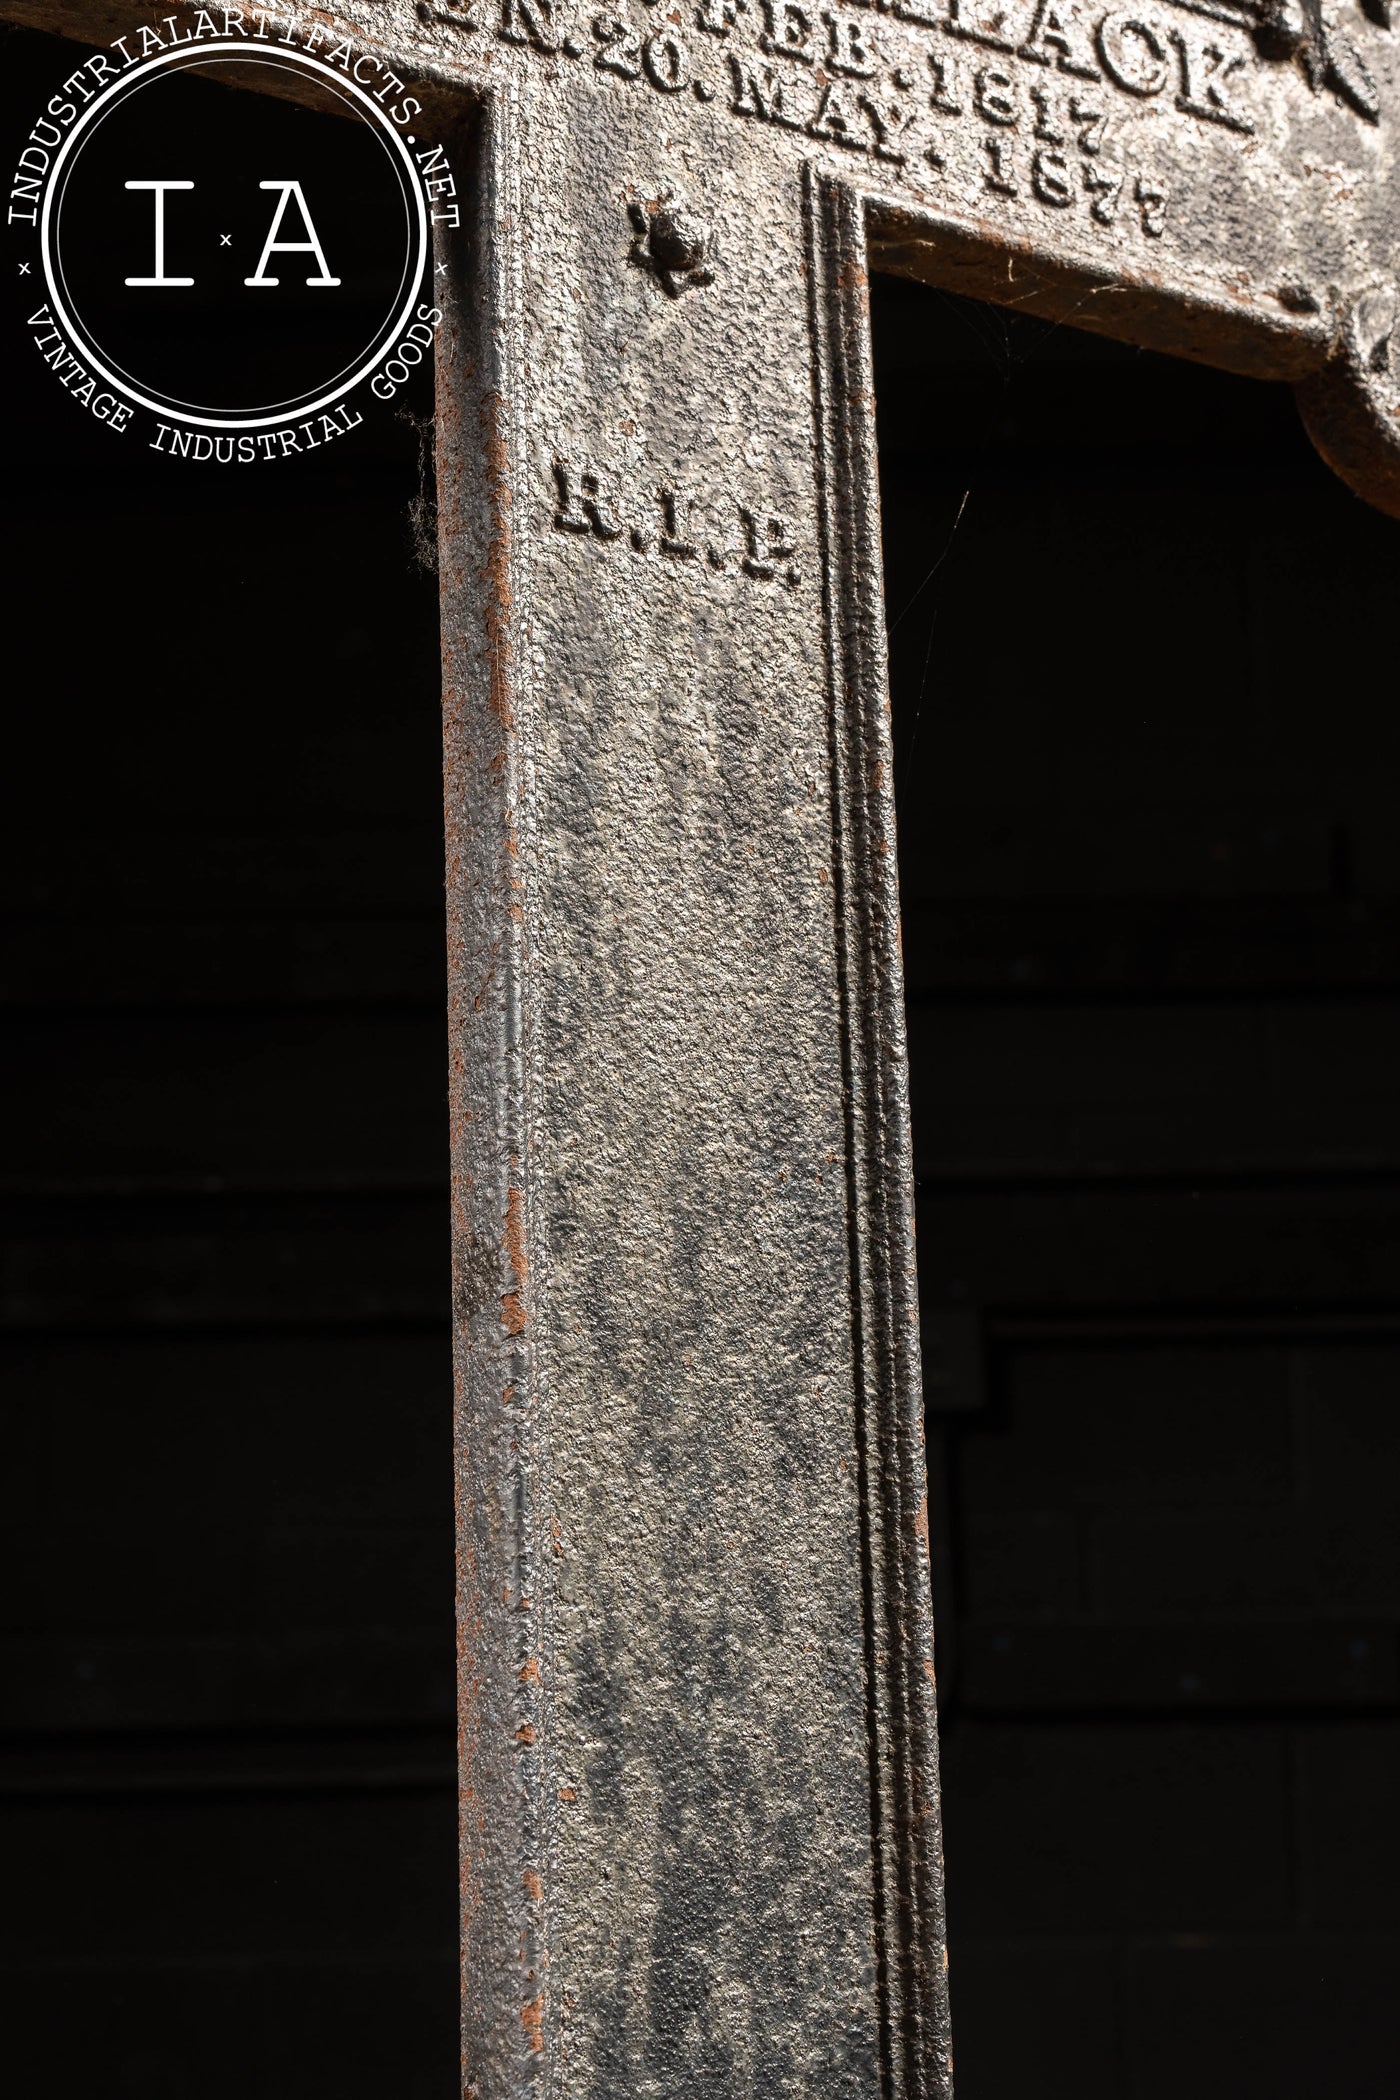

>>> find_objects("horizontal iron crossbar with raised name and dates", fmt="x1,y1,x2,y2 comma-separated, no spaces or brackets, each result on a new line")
16,0,1400,497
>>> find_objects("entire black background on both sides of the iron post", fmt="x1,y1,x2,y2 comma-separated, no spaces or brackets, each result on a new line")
0,20,1400,2100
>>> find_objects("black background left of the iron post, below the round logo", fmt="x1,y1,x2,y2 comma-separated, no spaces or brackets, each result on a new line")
0,34,458,2100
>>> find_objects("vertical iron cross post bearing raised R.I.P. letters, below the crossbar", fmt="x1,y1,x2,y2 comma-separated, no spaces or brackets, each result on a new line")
439,61,949,2100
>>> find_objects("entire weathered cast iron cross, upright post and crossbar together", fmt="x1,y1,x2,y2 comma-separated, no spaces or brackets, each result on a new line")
10,0,1400,2100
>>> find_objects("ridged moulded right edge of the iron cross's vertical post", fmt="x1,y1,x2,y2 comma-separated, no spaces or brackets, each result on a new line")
804,164,953,2100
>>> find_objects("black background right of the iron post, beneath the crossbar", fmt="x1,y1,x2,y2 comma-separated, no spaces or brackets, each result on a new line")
875,281,1400,2100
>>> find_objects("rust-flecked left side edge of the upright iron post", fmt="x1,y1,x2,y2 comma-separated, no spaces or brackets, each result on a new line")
437,82,563,2094
